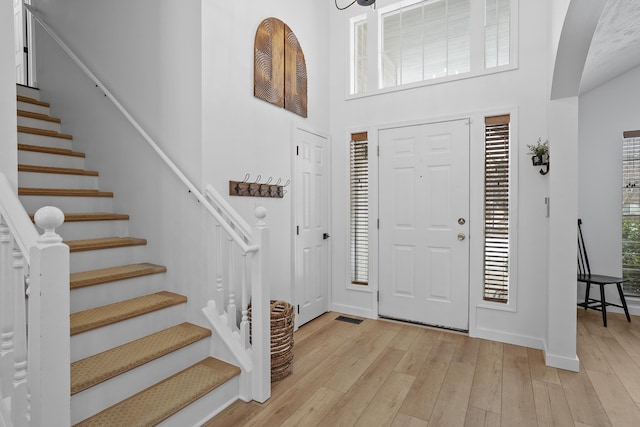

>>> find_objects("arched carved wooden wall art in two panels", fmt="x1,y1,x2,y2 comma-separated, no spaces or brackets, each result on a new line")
253,18,307,117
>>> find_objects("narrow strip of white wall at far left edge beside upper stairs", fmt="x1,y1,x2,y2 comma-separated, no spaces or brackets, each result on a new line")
0,1,18,188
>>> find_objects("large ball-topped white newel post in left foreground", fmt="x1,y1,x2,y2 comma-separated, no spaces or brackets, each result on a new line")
28,206,71,426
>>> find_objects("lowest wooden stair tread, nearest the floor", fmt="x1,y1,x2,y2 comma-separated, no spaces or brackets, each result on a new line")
75,357,240,427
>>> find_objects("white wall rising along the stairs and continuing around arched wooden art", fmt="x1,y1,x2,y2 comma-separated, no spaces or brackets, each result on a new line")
36,0,329,310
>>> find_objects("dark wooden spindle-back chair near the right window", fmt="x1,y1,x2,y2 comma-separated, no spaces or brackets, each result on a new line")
578,219,631,328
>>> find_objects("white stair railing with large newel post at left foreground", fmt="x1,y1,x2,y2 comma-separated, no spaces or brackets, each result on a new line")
0,173,71,427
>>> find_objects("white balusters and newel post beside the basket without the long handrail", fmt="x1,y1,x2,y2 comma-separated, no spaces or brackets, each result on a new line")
203,207,271,402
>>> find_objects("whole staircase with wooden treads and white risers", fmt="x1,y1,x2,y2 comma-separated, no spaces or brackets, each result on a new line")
17,86,240,426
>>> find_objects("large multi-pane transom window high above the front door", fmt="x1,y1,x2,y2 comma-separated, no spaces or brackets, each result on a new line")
350,0,518,95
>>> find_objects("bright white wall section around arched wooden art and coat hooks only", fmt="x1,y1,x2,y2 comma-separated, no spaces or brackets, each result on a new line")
202,0,329,301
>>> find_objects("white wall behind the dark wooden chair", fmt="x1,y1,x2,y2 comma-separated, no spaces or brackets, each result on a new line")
578,67,640,314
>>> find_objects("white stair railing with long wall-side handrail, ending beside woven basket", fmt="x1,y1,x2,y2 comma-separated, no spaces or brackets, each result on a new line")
24,4,271,402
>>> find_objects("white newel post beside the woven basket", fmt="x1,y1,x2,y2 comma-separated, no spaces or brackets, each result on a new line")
251,206,271,403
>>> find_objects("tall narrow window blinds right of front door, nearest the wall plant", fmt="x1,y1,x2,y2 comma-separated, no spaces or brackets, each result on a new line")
484,115,509,303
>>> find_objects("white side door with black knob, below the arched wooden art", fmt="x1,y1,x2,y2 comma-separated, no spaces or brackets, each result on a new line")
295,129,329,326
